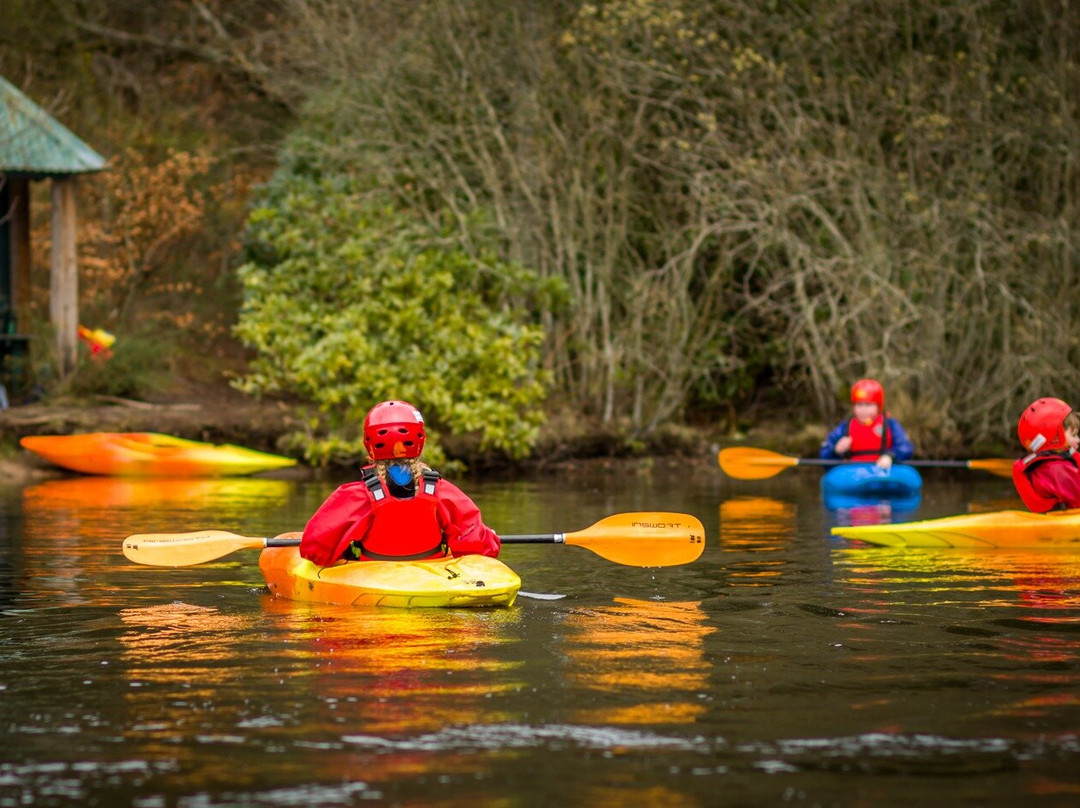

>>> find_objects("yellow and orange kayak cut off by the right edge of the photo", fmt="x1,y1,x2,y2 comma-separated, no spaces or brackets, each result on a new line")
833,510,1080,549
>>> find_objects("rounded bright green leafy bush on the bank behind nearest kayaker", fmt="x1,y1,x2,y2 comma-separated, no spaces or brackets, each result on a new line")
235,171,545,463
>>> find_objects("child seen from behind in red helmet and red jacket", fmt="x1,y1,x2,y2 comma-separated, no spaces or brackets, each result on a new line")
300,401,500,567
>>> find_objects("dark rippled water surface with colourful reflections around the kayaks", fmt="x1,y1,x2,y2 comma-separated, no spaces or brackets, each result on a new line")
0,464,1080,808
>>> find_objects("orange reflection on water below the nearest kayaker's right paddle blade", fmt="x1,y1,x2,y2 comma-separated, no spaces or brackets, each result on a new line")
564,598,716,725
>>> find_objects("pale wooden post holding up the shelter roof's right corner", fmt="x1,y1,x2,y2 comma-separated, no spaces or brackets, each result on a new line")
49,176,79,378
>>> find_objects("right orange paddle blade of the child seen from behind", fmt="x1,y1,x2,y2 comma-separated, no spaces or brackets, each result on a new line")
564,511,705,567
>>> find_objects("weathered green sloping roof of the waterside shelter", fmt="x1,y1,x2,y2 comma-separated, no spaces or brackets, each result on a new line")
0,76,105,176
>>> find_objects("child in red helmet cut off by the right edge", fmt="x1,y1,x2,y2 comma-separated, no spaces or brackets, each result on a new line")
1013,399,1080,513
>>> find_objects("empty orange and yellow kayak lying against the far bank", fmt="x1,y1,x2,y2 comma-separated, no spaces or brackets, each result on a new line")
19,432,296,477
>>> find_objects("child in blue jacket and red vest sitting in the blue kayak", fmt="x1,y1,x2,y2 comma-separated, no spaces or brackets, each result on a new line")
819,379,915,470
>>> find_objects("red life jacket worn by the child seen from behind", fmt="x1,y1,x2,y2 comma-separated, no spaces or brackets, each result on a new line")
353,467,446,561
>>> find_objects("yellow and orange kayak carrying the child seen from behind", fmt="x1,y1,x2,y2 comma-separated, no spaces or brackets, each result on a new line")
259,547,522,607
